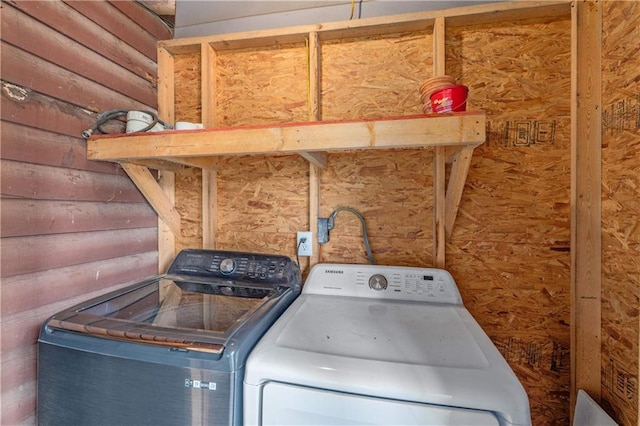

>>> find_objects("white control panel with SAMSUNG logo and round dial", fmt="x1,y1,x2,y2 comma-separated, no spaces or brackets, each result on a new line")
302,264,462,304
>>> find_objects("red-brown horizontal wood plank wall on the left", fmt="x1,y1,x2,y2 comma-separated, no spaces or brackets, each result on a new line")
0,1,172,425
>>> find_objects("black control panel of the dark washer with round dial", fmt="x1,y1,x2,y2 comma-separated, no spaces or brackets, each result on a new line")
167,249,300,285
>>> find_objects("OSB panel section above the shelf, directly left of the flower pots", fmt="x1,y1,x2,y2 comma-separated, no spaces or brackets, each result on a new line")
322,31,433,120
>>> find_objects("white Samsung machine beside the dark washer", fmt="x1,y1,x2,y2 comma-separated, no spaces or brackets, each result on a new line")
244,264,531,425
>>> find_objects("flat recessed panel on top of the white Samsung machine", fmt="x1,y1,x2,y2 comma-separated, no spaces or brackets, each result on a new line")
276,295,489,369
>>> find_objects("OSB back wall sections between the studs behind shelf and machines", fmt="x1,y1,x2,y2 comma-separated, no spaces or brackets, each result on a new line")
175,17,571,425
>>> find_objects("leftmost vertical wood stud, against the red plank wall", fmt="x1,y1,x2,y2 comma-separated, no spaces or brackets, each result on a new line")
158,47,177,273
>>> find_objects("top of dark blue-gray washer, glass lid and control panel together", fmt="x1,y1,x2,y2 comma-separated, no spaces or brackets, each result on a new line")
46,249,300,356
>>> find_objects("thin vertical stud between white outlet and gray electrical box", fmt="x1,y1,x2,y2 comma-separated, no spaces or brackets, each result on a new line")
308,32,326,268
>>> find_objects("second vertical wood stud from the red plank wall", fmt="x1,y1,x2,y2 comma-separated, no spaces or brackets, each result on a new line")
200,43,218,249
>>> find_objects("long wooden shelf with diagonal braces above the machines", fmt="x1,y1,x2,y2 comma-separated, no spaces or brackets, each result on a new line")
87,112,486,266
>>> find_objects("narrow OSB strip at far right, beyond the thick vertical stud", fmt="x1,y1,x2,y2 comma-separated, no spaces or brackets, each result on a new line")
602,2,640,425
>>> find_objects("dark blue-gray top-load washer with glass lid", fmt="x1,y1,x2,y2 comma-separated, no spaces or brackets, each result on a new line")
37,250,301,426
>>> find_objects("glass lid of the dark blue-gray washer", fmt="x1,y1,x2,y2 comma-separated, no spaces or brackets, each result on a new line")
47,278,282,355
